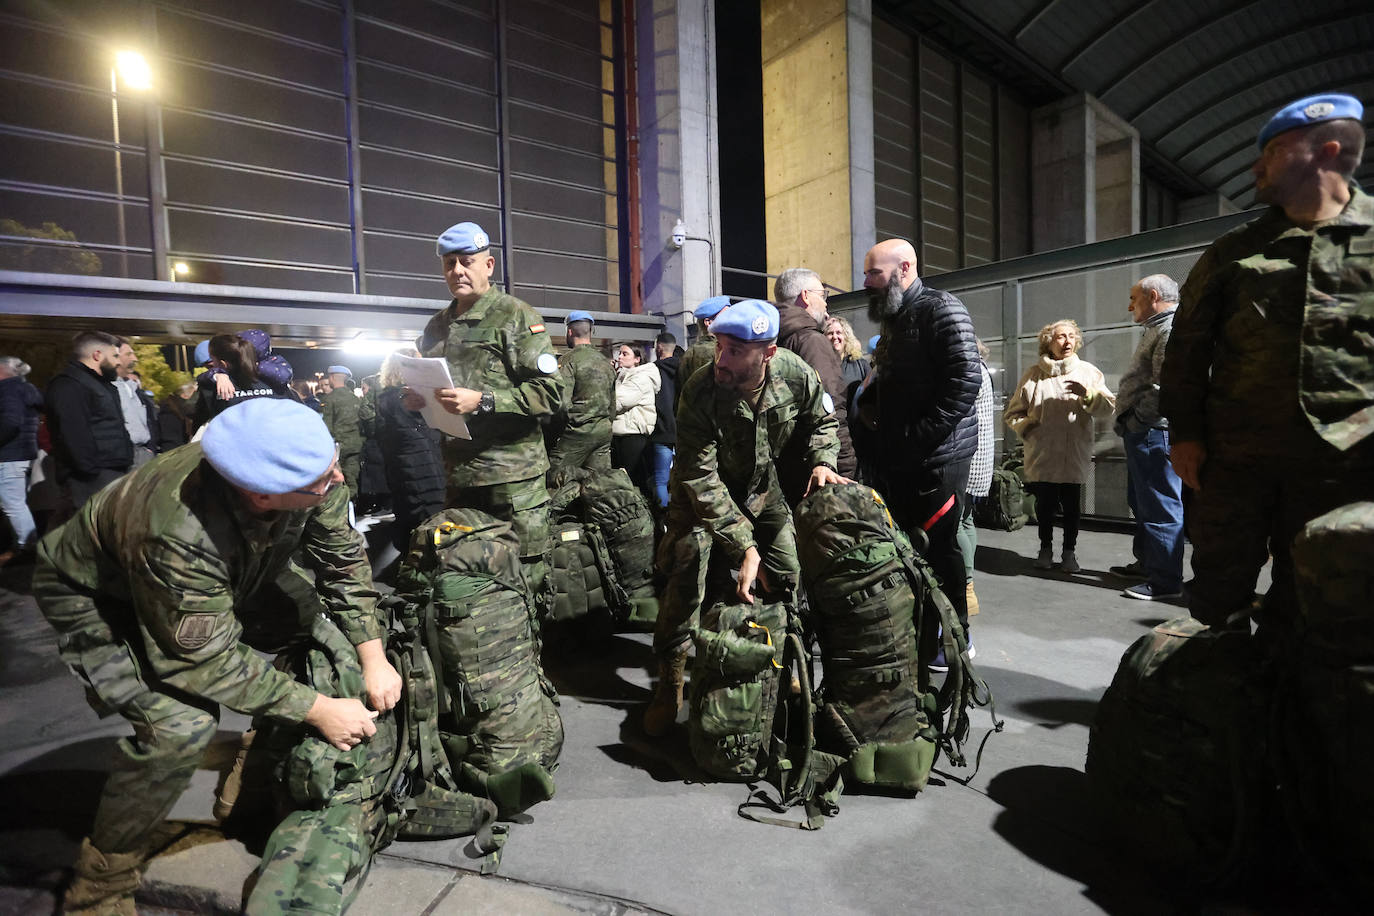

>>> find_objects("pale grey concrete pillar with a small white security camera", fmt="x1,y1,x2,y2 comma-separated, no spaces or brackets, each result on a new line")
635,0,720,343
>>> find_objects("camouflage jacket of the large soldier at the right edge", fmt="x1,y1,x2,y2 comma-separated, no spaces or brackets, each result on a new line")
1160,184,1374,457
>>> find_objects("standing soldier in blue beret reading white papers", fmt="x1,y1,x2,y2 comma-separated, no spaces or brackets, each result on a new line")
405,222,563,614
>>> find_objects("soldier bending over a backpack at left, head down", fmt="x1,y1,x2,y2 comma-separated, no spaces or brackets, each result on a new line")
33,398,401,913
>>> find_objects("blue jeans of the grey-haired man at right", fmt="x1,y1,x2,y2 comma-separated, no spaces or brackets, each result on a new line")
1123,428,1183,592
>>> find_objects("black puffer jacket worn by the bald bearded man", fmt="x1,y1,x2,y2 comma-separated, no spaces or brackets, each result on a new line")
859,280,982,477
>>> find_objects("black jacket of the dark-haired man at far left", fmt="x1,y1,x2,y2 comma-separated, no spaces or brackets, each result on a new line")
44,360,133,481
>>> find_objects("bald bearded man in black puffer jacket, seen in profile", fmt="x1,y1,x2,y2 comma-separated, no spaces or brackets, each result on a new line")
859,239,982,655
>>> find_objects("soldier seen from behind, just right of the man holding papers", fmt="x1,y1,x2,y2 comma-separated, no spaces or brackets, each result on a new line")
548,312,616,471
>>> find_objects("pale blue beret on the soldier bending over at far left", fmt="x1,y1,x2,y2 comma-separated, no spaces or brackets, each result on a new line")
201,397,335,494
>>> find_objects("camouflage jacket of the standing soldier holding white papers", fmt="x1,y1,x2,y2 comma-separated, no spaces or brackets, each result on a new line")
415,287,563,486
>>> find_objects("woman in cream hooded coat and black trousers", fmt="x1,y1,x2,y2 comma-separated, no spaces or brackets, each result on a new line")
1003,320,1116,573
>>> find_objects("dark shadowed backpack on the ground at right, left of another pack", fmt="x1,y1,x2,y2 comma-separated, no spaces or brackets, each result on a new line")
1084,617,1272,886
